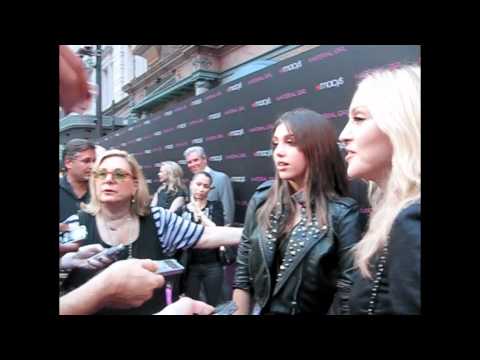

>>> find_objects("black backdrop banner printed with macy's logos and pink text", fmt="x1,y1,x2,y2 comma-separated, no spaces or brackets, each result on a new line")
96,45,420,223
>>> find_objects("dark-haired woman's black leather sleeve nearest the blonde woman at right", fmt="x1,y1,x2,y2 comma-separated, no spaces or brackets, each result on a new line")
328,199,361,315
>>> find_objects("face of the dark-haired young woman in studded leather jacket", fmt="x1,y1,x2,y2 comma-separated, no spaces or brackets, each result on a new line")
272,124,308,190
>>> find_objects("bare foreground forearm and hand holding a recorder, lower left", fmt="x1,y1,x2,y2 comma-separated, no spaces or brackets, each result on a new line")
60,259,165,315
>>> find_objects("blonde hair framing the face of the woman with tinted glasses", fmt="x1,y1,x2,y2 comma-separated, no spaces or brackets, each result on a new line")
82,149,150,216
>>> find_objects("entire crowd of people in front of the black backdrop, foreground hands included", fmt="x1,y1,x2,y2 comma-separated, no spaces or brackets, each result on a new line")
59,46,421,315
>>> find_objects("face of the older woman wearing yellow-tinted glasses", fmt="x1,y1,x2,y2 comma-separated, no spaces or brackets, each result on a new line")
94,156,138,204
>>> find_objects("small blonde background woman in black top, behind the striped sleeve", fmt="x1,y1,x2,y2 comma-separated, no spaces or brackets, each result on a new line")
150,161,187,212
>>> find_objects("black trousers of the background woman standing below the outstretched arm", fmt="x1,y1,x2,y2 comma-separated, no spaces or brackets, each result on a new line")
185,262,223,306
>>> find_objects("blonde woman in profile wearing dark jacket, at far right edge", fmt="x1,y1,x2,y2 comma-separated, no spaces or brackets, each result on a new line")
340,65,421,315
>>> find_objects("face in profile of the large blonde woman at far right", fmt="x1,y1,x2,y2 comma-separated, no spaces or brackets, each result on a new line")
339,93,393,186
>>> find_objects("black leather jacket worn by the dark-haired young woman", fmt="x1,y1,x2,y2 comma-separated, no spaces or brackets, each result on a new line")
233,182,361,314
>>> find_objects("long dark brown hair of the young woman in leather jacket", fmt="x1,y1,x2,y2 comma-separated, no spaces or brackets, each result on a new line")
258,108,348,236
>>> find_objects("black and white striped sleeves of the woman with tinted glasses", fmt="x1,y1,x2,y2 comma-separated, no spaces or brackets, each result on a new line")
60,207,205,254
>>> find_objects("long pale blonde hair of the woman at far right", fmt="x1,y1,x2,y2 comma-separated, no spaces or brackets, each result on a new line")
350,65,421,278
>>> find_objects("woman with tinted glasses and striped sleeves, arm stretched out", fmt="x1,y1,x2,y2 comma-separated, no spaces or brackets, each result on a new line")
65,150,241,314
